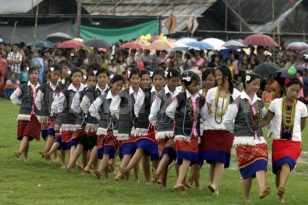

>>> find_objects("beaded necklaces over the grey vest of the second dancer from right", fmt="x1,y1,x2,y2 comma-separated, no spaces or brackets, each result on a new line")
241,99,261,137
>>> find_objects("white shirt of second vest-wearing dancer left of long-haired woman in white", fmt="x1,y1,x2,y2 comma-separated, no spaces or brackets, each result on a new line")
149,85,180,125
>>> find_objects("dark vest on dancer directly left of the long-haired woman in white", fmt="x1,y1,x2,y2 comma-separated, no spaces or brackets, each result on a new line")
175,92,205,137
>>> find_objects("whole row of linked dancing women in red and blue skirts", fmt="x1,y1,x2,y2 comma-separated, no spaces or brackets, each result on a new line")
11,66,307,203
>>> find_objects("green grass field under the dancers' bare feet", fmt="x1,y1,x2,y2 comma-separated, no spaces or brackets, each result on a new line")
0,100,308,205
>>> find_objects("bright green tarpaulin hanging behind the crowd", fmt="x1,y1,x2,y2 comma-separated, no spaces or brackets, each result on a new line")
74,20,158,44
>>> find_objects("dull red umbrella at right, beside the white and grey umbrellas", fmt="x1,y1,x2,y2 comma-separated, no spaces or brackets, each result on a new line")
243,34,277,46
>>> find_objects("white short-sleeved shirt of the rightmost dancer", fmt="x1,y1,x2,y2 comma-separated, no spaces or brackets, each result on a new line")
268,98,307,141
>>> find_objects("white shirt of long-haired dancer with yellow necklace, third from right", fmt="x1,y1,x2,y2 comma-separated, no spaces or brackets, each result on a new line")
202,87,241,130
